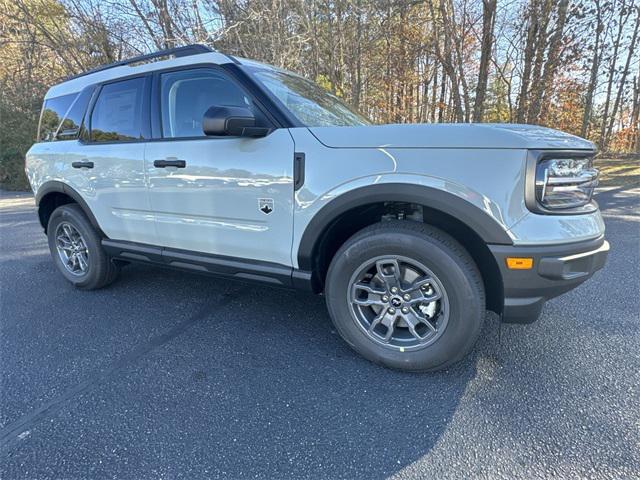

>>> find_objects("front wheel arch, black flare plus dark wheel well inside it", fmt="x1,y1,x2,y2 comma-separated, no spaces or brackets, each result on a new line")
297,183,513,313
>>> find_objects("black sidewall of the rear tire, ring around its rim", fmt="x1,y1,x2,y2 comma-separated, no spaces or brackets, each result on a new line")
47,205,103,288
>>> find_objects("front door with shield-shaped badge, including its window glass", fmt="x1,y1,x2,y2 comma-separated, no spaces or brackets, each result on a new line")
145,67,294,265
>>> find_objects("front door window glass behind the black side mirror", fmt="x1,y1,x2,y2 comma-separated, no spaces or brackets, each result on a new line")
160,68,258,138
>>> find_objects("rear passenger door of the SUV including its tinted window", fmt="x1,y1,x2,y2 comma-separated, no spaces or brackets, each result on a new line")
67,75,157,243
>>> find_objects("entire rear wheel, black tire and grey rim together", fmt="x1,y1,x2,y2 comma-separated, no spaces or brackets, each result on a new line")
47,204,119,290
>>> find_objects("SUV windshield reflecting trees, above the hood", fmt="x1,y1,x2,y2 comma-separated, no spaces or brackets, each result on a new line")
250,67,371,127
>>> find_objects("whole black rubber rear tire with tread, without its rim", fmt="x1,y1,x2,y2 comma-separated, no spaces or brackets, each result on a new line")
47,204,120,290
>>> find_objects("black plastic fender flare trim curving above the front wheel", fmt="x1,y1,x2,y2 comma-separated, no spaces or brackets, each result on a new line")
298,183,513,270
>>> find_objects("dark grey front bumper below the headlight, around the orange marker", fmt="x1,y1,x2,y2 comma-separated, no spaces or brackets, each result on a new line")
489,237,609,323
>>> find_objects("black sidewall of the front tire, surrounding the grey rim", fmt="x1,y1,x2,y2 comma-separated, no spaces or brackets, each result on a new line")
326,226,484,370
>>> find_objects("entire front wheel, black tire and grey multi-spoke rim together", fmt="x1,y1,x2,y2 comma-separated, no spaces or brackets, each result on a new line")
325,221,485,371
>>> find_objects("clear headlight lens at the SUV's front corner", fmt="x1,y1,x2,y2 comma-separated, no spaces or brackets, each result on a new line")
536,157,598,210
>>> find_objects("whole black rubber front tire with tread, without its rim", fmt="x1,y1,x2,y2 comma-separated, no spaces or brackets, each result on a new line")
325,220,485,371
